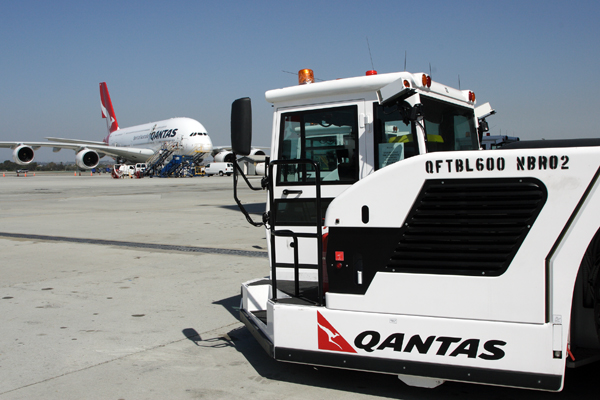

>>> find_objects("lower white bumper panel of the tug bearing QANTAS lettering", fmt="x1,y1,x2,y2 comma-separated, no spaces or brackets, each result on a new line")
273,305,564,375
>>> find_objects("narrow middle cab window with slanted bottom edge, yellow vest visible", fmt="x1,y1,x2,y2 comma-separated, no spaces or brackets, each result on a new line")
374,103,419,169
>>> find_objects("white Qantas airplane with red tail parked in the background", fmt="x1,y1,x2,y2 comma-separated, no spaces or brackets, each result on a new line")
0,82,216,169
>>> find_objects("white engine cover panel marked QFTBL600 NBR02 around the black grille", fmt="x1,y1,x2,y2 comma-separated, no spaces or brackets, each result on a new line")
325,148,600,324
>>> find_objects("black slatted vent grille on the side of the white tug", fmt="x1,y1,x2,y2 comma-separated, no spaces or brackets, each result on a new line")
386,178,547,276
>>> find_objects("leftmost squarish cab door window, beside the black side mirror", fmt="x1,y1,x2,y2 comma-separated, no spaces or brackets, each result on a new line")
277,106,358,184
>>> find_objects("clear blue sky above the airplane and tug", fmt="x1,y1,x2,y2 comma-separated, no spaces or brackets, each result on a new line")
0,0,600,161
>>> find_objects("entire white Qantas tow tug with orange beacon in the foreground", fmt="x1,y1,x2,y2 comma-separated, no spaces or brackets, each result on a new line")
231,70,600,391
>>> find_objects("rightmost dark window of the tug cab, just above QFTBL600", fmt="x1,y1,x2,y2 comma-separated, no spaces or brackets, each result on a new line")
421,95,479,153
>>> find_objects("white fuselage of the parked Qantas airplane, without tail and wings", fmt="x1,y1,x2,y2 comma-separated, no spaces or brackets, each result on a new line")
108,118,213,161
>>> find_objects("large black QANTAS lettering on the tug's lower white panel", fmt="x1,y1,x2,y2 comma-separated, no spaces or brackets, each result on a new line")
354,331,506,360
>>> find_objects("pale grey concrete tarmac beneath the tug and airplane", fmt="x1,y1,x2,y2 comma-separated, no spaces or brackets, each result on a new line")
0,173,600,400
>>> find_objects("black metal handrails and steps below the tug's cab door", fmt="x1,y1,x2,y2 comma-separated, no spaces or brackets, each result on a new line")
268,159,325,306
